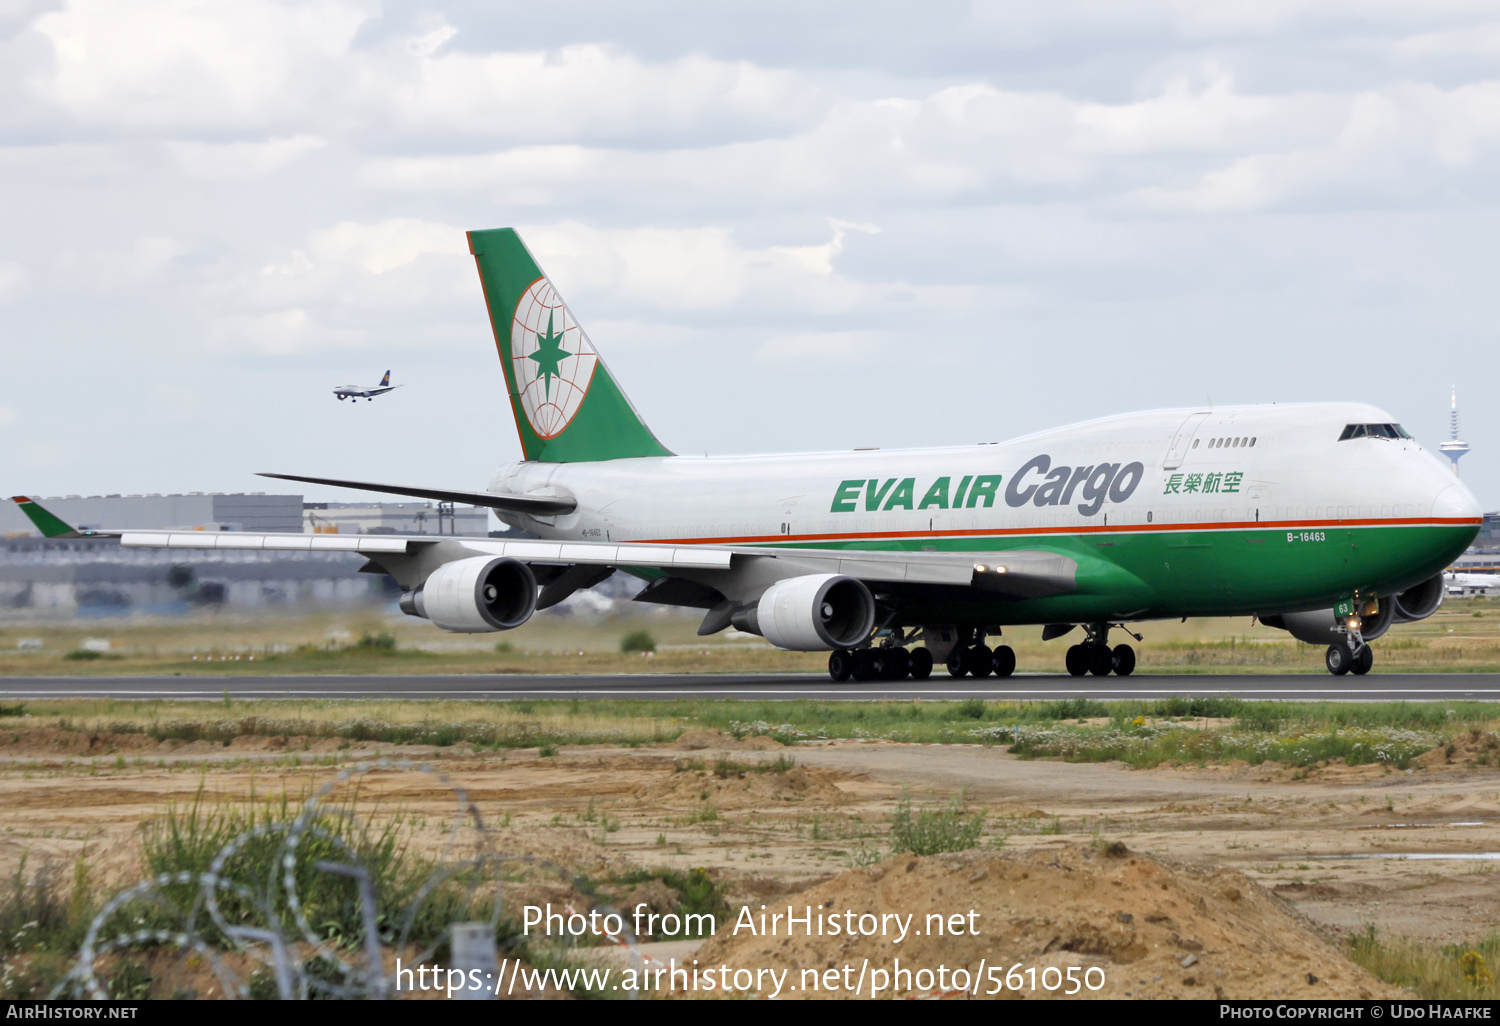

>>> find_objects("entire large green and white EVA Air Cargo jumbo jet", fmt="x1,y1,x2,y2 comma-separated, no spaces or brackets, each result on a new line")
14,228,1482,681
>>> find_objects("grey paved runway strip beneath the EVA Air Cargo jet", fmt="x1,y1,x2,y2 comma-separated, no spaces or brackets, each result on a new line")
0,674,1500,702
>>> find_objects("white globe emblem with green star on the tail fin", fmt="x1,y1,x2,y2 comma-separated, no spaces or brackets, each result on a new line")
510,278,599,438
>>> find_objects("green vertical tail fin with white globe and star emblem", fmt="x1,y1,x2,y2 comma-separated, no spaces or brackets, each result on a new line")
468,228,672,464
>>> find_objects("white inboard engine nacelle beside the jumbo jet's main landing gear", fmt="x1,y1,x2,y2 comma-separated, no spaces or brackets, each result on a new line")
735,573,875,653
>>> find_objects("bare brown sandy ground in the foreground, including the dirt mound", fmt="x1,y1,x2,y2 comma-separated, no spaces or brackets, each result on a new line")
0,728,1500,998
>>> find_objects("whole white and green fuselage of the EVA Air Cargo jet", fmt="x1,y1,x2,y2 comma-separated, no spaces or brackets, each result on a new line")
491,404,1481,624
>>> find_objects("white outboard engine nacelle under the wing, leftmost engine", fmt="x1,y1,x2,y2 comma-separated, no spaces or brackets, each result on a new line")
401,557,537,635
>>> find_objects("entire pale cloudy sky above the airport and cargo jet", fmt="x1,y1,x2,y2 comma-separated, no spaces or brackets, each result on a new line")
0,0,1500,509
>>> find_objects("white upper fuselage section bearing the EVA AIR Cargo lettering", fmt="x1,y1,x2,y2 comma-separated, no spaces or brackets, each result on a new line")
489,404,1479,548
